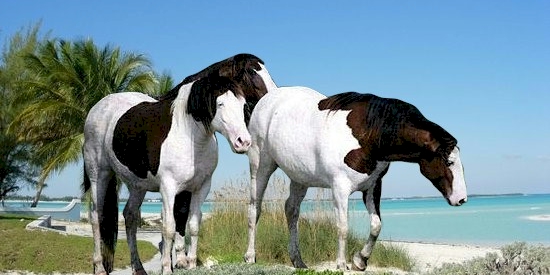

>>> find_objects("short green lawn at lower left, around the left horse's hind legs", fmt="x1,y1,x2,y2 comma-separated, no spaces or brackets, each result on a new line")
0,215,157,273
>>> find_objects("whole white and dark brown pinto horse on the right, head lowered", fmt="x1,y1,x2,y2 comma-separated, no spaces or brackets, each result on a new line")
245,87,467,270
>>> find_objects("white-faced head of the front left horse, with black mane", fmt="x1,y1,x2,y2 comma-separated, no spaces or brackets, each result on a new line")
187,76,251,154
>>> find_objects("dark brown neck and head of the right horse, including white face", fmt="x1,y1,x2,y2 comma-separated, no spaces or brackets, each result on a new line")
319,92,467,206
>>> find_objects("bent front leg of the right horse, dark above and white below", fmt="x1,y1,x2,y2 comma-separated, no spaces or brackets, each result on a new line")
352,177,382,271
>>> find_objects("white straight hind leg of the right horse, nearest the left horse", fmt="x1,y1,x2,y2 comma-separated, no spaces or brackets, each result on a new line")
244,149,277,263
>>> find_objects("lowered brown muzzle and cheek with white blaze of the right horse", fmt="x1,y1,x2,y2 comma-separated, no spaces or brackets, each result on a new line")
419,146,468,206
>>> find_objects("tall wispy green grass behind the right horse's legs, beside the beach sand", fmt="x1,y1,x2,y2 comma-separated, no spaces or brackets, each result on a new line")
198,203,413,271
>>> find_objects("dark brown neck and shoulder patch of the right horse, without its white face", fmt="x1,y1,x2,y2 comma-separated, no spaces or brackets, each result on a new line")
318,92,456,174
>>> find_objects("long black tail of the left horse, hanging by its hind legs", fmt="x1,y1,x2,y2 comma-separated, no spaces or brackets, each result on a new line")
82,164,118,272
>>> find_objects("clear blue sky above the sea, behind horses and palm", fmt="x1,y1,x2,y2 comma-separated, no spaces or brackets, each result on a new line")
0,0,550,197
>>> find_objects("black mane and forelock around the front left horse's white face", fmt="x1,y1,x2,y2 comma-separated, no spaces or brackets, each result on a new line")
186,75,244,131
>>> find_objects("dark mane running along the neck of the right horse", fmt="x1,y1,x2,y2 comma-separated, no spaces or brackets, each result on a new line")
319,92,457,159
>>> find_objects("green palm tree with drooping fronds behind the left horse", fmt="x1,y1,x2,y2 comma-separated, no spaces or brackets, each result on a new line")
10,39,158,205
